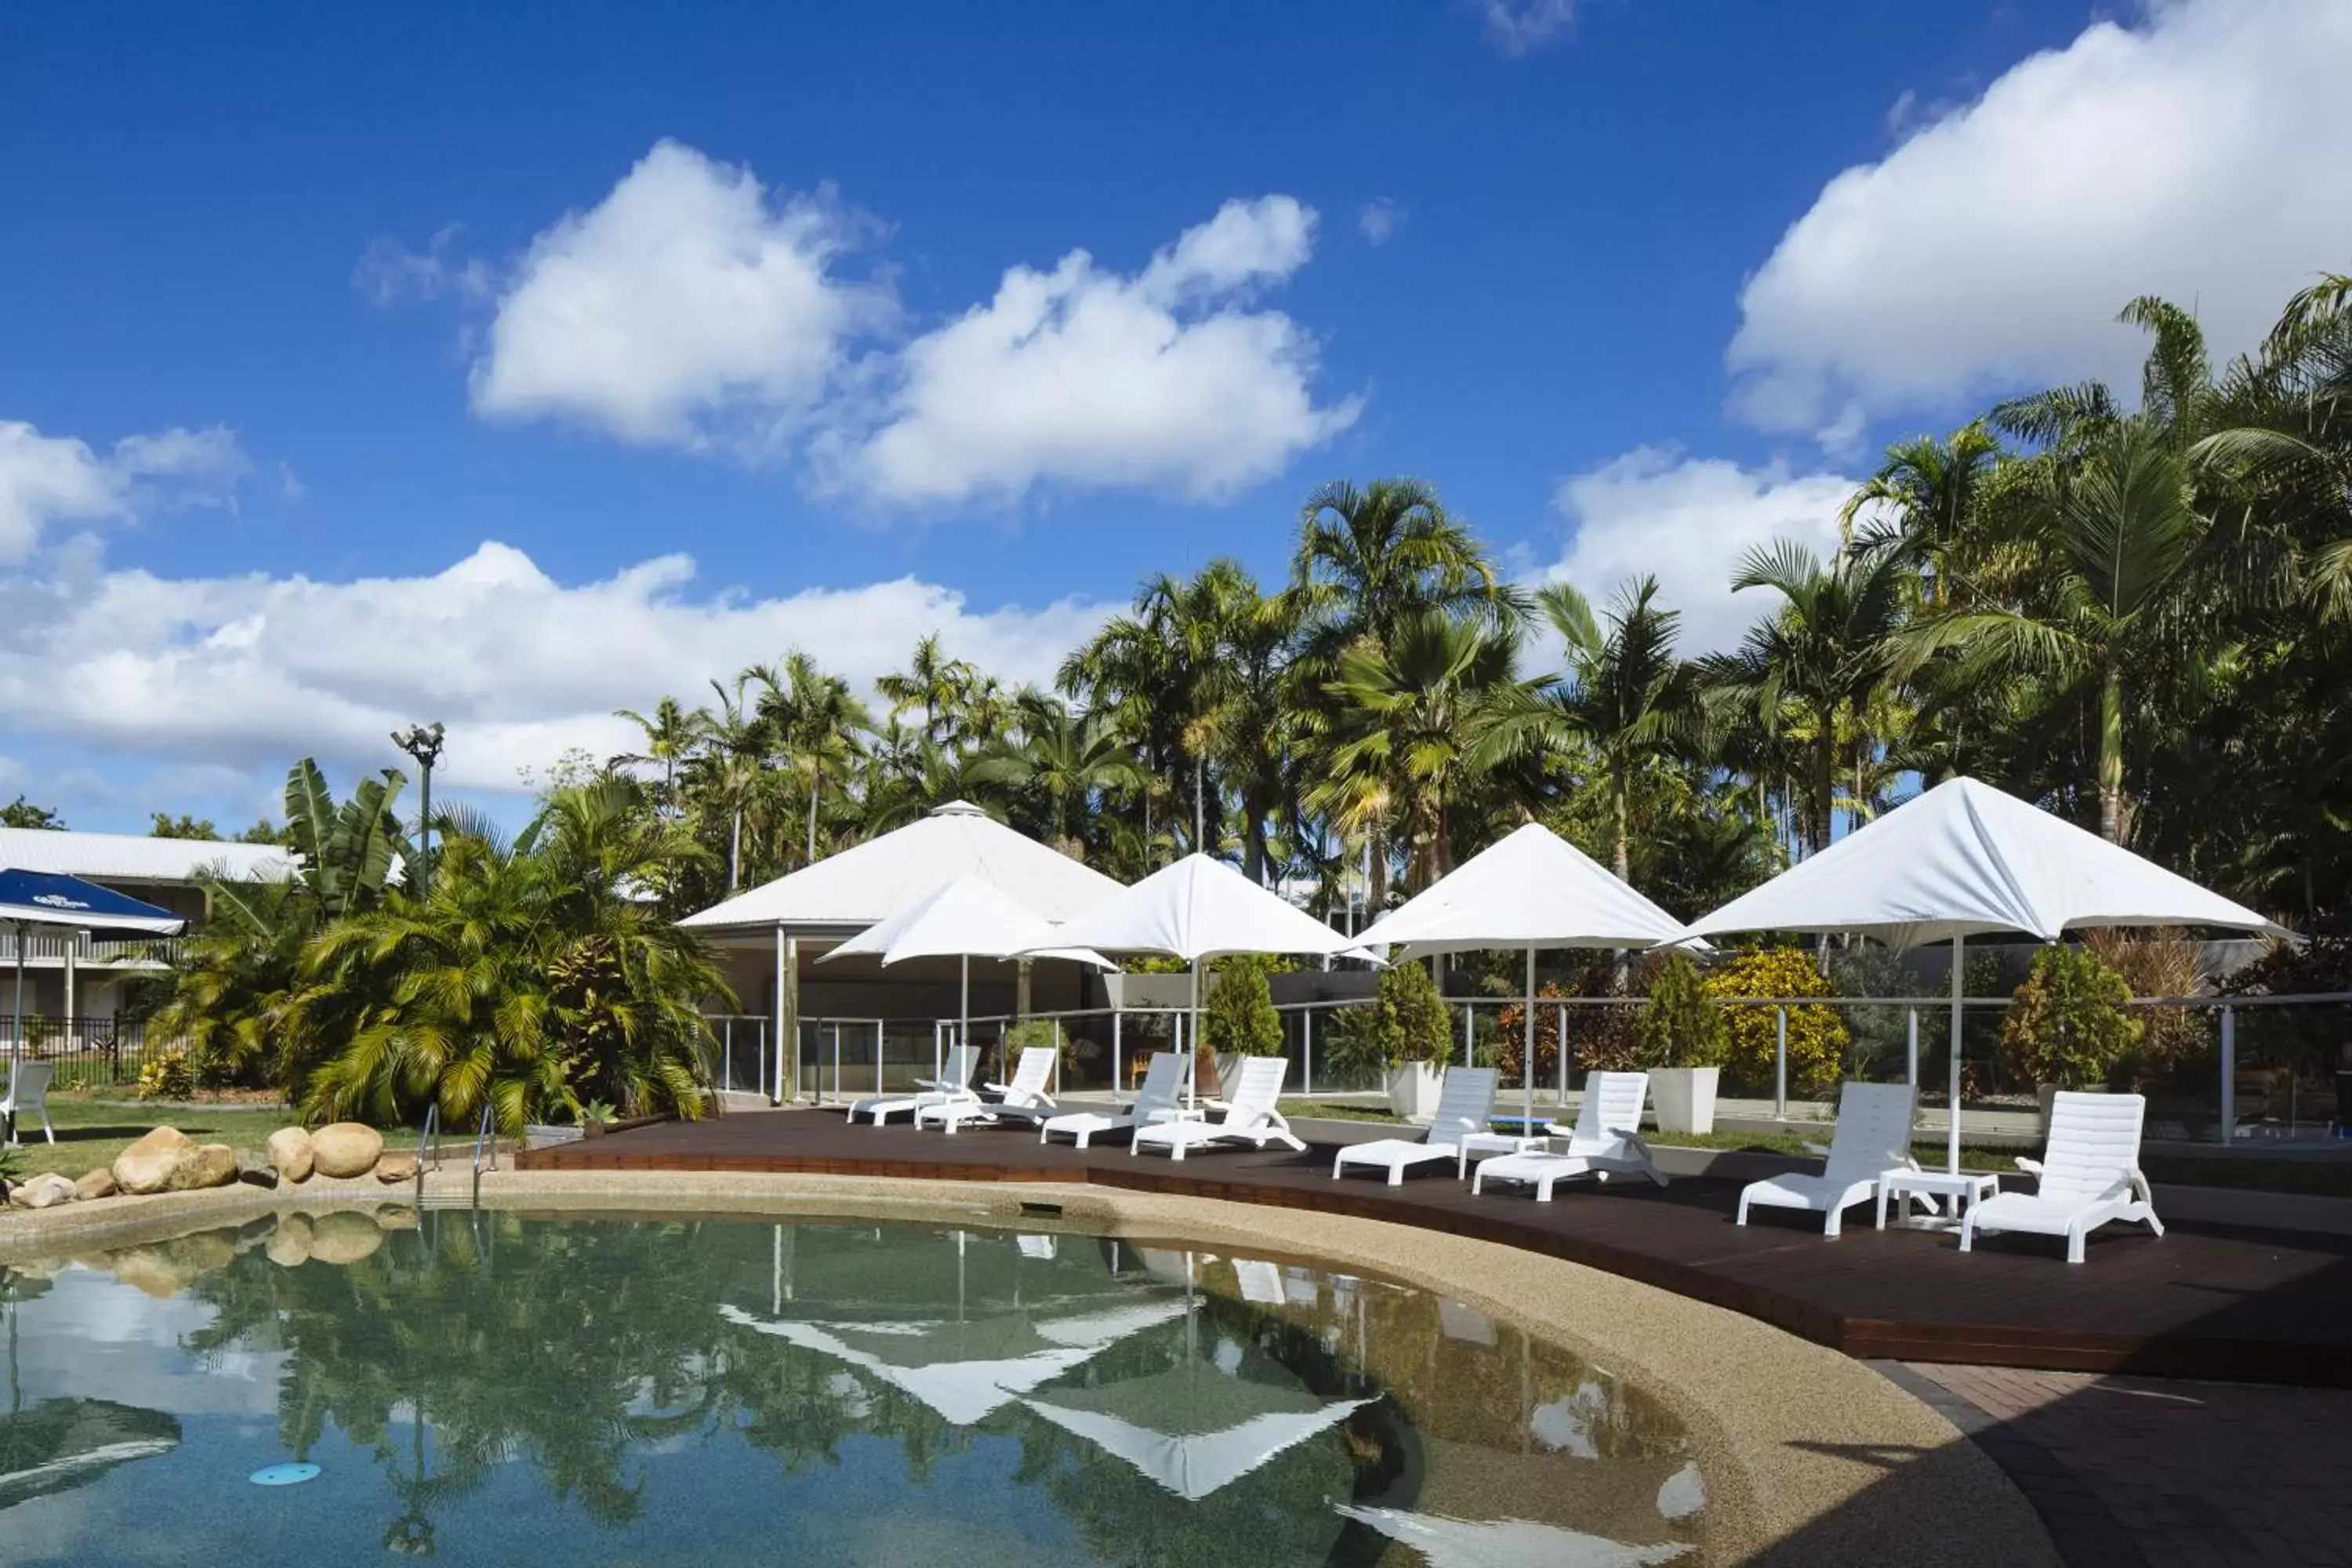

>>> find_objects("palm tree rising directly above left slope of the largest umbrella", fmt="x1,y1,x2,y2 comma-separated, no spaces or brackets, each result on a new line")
1708,541,1905,851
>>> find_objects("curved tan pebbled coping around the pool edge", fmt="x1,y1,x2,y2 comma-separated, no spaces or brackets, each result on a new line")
0,1171,2060,1568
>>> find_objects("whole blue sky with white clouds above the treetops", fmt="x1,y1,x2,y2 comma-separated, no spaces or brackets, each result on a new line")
0,0,2352,827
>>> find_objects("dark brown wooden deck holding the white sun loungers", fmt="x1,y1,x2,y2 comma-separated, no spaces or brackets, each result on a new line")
517,1112,2352,1387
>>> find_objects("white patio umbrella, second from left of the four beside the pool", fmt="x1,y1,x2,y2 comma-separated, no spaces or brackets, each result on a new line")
1025,853,1364,1095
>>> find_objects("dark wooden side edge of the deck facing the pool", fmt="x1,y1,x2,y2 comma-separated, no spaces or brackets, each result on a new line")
515,1145,2352,1387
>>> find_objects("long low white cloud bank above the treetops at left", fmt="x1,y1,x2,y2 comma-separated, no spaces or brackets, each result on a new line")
0,543,1108,789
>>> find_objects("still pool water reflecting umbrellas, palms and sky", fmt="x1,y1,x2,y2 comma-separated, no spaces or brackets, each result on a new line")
0,1210,1705,1568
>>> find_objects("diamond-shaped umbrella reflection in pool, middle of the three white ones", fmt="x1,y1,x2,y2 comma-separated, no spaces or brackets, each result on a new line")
1021,1366,1371,1502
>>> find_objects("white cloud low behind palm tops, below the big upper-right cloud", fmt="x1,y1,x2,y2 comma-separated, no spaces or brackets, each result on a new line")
1548,447,1856,654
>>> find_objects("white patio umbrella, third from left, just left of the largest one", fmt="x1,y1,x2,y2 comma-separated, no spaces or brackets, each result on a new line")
1355,822,1684,1142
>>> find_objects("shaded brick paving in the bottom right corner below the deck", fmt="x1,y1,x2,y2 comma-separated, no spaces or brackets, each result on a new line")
1898,1363,2352,1568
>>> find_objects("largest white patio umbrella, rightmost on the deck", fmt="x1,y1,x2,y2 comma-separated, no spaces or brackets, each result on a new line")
1689,779,2284,1171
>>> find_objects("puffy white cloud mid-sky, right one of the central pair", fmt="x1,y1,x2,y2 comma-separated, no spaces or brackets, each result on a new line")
816,195,1359,506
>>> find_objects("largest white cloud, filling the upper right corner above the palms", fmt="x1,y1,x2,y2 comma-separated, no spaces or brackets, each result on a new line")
1726,0,2352,430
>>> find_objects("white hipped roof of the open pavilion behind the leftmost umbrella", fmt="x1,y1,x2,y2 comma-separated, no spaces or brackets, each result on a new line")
680,799,1120,931
